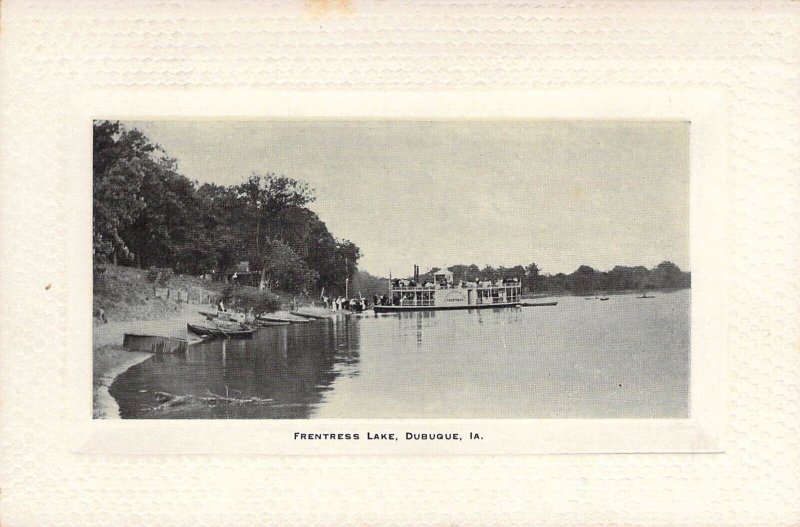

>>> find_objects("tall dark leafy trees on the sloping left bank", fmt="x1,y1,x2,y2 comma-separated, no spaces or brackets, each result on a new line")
92,121,361,292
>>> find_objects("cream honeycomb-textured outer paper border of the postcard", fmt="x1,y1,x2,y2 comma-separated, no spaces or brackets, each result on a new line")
0,1,800,527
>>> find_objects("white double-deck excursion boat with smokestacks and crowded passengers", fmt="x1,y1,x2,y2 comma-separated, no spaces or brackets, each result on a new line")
374,268,522,313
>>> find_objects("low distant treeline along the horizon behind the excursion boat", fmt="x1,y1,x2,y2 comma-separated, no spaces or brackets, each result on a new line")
354,262,692,295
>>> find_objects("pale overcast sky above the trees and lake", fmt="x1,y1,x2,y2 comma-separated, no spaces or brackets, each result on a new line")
122,119,691,276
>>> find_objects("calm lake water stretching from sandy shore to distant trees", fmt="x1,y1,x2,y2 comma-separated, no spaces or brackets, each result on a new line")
110,290,691,419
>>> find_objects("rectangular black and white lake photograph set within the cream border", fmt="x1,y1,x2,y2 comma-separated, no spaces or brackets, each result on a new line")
92,118,691,419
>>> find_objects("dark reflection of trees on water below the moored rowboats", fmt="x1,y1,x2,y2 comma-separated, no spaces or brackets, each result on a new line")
110,319,360,418
